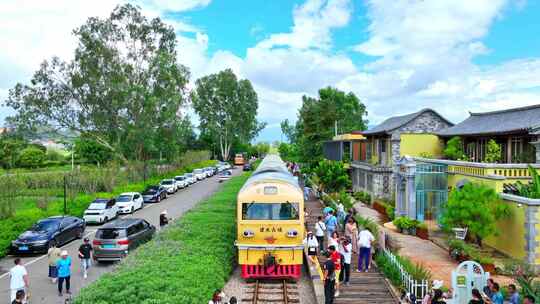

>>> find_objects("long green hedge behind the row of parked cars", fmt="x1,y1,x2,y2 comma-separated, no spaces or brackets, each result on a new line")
0,160,215,257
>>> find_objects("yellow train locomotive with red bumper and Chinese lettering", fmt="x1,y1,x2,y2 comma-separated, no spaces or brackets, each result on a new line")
236,155,304,279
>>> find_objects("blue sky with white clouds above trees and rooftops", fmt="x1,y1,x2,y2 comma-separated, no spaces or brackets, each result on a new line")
0,0,540,141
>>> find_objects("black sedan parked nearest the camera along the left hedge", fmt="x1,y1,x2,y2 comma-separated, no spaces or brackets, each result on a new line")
11,216,86,254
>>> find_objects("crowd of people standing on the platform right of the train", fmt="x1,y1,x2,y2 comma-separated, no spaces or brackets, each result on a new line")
304,204,375,304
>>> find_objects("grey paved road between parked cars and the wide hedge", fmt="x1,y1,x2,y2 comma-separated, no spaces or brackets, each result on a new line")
0,169,241,304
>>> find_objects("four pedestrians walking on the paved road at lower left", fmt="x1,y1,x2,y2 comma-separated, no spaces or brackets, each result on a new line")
9,238,93,304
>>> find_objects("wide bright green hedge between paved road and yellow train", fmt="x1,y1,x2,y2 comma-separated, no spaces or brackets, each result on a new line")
75,174,249,304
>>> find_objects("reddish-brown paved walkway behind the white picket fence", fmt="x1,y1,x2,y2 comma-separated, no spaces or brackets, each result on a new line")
355,203,512,287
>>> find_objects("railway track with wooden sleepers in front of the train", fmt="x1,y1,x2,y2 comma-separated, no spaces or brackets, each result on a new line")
242,280,300,304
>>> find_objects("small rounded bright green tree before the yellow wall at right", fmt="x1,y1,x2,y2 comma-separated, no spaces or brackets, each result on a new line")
441,183,510,246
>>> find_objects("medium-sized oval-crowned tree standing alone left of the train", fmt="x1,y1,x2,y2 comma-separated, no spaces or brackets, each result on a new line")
191,69,265,160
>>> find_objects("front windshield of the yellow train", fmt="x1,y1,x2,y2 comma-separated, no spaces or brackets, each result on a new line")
242,202,300,221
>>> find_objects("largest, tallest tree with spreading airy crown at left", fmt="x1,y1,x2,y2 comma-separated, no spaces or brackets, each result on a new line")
7,4,189,160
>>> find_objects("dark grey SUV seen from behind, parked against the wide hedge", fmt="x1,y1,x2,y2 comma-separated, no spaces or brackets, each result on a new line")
92,218,156,262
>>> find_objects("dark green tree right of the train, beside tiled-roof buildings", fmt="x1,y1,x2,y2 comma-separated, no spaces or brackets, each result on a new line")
281,87,367,166
